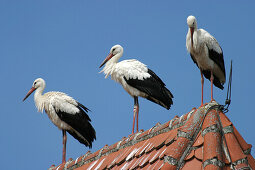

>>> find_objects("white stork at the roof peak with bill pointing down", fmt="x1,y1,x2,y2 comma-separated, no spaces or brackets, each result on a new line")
186,16,226,106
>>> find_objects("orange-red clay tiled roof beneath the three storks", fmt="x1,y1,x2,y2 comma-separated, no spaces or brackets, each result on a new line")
50,102,255,170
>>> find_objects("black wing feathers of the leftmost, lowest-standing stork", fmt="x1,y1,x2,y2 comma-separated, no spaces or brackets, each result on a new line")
55,103,96,148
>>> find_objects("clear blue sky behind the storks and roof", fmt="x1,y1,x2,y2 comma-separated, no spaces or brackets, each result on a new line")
0,0,255,169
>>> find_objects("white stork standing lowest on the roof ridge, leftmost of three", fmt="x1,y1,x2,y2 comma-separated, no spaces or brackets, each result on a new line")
23,78,96,163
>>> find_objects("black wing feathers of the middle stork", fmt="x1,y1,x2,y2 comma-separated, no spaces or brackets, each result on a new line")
124,69,173,109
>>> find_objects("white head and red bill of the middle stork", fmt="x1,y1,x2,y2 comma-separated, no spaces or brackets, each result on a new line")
99,44,123,68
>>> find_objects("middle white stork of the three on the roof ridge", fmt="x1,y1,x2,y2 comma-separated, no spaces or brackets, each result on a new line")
99,45,173,133
